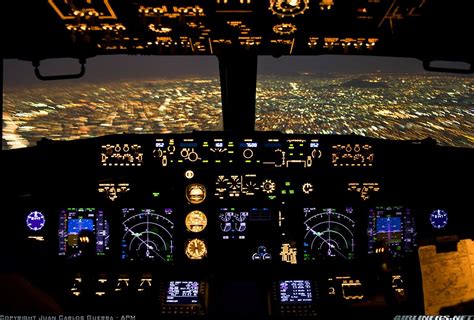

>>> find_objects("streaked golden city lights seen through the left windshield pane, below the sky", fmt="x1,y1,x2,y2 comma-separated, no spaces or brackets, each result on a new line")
2,79,221,149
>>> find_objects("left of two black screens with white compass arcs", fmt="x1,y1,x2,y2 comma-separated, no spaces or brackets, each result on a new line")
121,208,174,262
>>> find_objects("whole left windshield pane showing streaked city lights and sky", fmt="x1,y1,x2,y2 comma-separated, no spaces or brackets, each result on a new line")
2,56,222,150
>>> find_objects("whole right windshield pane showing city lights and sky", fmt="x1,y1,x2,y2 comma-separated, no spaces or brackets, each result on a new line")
256,56,474,148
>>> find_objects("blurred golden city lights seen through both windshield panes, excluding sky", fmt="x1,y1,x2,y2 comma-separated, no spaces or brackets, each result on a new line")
2,74,474,149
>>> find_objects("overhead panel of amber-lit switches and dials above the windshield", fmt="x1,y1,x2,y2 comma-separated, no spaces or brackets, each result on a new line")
48,0,427,56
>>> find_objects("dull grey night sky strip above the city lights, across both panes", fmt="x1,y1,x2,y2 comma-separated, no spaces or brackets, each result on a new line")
4,55,468,88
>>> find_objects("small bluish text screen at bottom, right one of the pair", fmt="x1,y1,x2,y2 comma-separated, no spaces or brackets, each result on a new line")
280,280,313,304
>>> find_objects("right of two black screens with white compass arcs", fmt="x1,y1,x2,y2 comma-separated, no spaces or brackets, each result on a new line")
303,207,355,261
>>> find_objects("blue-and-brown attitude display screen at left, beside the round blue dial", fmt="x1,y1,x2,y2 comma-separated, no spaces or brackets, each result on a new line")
58,208,109,259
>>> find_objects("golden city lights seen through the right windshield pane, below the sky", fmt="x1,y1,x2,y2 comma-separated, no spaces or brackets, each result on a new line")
257,75,474,147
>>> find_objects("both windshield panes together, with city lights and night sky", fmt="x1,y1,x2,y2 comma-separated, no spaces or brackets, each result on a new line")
2,56,474,150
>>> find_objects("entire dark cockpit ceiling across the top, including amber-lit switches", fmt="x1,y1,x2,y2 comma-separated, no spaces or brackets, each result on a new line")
2,0,474,69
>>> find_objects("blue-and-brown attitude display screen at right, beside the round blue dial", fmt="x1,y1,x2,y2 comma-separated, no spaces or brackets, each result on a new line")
367,207,416,257
